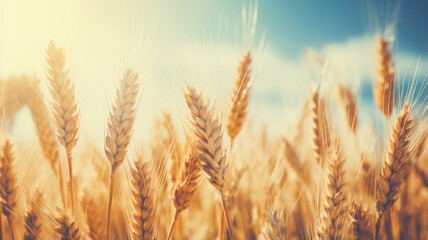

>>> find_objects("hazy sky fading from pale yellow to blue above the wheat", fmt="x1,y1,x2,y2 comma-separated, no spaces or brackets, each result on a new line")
0,0,428,148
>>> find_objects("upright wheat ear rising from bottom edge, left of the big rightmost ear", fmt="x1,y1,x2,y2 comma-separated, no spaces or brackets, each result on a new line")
319,152,349,239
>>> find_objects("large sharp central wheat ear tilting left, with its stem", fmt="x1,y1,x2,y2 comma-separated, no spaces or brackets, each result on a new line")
184,86,233,238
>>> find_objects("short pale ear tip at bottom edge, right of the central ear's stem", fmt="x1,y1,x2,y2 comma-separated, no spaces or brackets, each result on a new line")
267,209,287,240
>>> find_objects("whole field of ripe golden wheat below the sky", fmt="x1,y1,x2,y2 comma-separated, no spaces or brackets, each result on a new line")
0,0,428,240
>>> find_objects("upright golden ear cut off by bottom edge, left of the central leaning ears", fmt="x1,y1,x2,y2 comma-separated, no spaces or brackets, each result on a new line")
131,160,155,240
